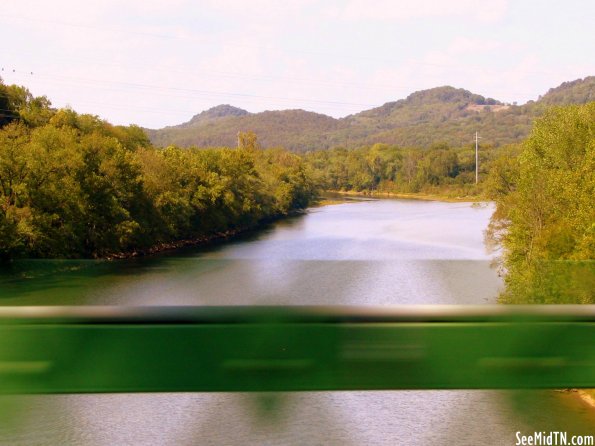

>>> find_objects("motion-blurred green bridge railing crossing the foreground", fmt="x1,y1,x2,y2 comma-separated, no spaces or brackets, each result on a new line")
0,305,595,393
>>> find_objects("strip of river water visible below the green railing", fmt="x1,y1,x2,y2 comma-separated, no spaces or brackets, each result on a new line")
0,391,595,446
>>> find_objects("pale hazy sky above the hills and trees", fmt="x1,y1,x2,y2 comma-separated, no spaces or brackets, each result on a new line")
0,0,595,128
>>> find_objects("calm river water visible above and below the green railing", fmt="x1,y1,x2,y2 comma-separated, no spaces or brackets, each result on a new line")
0,200,595,445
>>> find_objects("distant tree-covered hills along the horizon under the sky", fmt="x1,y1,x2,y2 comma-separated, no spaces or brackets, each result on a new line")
147,76,595,151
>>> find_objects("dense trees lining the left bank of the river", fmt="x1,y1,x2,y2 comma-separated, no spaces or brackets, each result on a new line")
0,80,315,260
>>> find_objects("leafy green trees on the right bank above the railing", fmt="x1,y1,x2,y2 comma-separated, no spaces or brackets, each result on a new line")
490,102,595,303
